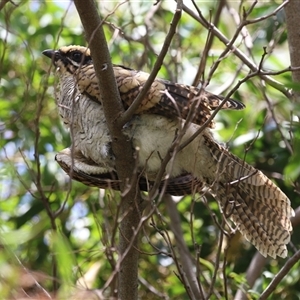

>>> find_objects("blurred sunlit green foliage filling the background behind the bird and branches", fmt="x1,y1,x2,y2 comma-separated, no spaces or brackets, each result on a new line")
0,1,300,299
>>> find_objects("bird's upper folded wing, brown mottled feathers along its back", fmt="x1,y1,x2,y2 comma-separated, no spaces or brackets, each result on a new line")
76,65,244,127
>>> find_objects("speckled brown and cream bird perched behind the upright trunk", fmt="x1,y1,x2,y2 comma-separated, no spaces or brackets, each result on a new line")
43,45,294,258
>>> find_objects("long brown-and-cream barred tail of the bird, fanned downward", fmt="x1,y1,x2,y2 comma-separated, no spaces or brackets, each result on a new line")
204,136,294,258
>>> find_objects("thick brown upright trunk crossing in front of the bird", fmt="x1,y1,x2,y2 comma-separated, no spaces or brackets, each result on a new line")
74,0,141,300
